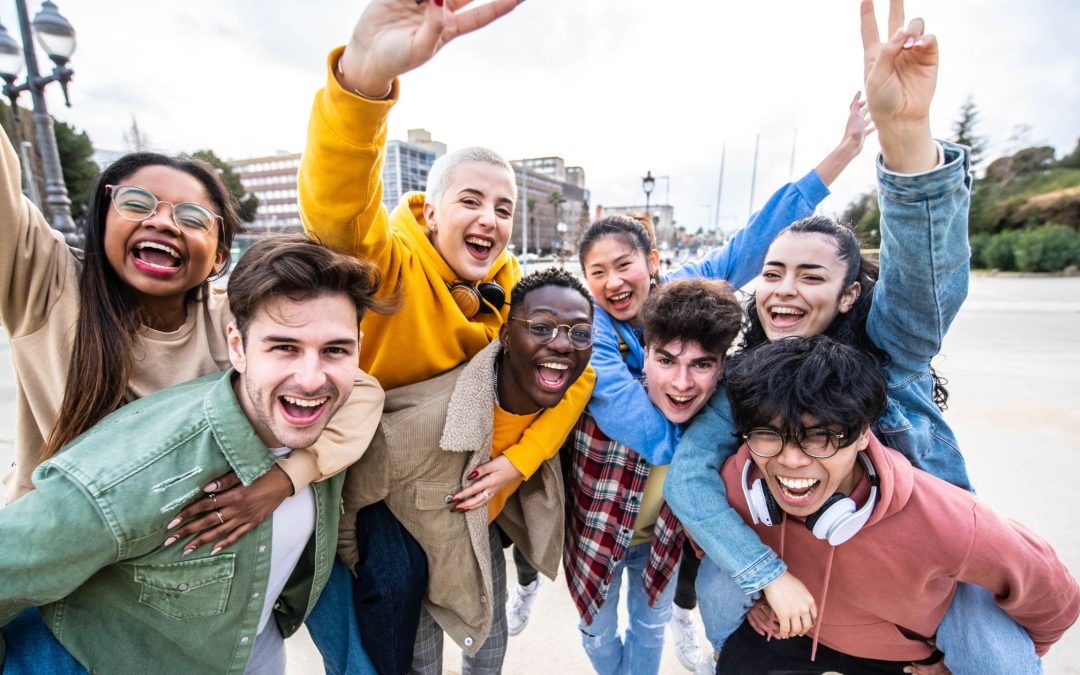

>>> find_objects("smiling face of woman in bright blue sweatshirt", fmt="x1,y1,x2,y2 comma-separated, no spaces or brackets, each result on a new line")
581,234,660,324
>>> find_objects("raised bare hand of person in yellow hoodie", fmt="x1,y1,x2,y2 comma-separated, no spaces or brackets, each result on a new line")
338,0,521,98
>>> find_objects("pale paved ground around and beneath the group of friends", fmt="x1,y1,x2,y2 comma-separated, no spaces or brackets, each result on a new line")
0,276,1080,675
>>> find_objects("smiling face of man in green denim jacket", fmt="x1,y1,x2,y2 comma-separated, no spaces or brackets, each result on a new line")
228,293,360,448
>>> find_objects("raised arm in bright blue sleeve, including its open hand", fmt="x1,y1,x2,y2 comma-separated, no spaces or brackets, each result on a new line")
673,98,874,287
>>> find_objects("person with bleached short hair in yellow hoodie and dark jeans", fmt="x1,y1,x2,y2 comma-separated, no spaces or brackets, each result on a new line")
299,0,595,672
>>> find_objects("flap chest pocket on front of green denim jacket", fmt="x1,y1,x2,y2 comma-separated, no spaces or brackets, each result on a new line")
135,553,235,619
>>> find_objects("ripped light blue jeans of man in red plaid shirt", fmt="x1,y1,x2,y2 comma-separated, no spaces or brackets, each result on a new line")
578,541,675,675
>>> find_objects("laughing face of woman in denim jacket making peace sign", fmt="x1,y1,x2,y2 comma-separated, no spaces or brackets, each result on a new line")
754,232,860,340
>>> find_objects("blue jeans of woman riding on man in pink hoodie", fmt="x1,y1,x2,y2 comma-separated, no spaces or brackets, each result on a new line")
698,557,1042,675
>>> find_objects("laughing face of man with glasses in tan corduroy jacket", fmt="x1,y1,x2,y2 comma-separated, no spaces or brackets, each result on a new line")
499,285,593,415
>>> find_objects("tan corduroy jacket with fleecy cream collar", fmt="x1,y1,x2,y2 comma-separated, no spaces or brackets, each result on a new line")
338,341,564,654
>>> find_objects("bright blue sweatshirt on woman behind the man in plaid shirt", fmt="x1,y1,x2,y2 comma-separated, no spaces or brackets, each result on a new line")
589,170,828,465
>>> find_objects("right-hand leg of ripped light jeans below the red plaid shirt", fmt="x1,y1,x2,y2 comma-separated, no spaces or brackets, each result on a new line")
622,541,677,675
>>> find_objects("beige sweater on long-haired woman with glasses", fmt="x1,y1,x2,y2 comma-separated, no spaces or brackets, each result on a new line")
0,132,383,502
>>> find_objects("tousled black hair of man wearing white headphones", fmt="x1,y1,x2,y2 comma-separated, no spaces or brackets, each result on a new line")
725,335,889,442
